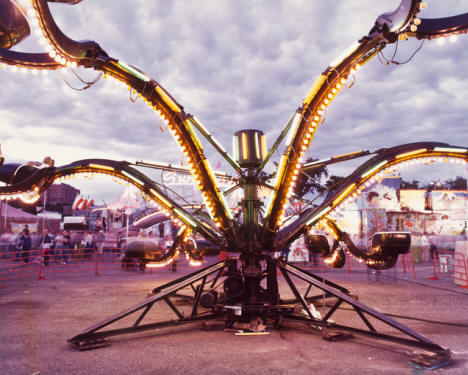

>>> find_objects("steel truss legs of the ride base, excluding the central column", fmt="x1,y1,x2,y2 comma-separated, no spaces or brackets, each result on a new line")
68,257,450,368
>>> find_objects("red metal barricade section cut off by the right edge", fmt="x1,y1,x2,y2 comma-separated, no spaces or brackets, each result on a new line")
429,250,468,288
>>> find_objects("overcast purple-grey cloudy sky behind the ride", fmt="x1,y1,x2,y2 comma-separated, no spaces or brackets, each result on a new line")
0,0,468,203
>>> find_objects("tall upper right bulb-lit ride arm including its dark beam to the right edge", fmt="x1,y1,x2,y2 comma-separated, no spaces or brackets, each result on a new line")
264,0,468,245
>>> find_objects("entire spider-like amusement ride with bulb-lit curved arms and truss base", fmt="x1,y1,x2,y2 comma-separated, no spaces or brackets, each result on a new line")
0,0,468,368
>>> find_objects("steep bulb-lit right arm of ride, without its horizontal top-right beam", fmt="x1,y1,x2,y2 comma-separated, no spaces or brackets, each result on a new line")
263,0,421,242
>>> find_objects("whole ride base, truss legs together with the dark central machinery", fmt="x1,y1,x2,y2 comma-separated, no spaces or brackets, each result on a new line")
68,256,451,369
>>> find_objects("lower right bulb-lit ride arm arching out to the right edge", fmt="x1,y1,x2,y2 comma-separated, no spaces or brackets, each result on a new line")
275,142,468,253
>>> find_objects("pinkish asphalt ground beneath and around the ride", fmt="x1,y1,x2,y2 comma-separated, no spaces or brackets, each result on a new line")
0,259,468,375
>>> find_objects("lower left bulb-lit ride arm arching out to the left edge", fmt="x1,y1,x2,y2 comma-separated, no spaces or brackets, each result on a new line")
0,159,223,245
